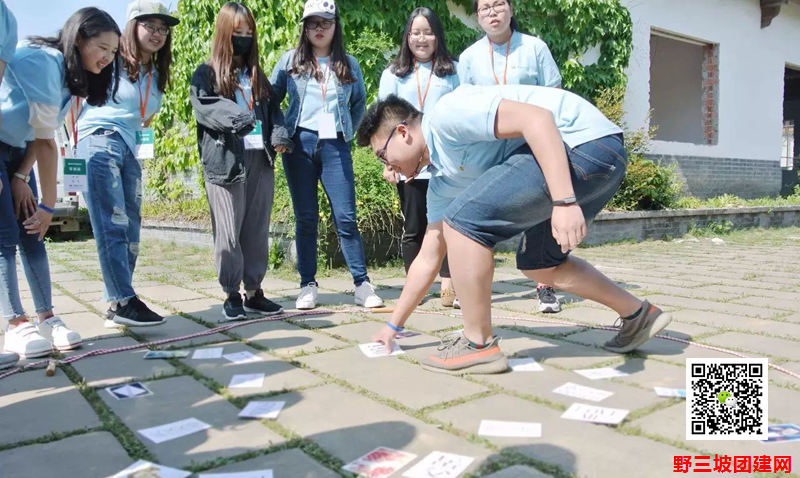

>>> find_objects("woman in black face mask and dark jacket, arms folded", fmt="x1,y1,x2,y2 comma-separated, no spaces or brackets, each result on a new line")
190,2,293,320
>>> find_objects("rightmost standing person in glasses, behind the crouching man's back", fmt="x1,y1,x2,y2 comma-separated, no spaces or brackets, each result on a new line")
458,0,561,313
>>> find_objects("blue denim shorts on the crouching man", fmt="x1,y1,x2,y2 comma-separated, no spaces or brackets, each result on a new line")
444,134,628,270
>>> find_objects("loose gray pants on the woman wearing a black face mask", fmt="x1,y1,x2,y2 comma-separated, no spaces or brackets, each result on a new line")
206,150,275,294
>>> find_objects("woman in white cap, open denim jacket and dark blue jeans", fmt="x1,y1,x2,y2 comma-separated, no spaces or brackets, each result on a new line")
271,0,383,309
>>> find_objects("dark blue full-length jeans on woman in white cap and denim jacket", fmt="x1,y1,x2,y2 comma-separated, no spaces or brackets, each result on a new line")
283,128,369,287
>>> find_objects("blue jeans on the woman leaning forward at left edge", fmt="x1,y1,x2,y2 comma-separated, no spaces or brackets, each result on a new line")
0,143,53,320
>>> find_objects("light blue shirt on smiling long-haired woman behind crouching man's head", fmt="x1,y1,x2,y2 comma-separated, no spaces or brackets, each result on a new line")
378,62,458,179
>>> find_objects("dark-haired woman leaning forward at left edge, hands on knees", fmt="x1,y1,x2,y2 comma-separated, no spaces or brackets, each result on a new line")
0,7,120,358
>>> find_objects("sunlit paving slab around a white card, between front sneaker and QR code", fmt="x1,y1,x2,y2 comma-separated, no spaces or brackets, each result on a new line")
473,360,664,411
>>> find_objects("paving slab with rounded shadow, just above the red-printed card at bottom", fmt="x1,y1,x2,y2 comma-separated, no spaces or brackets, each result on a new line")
273,385,490,476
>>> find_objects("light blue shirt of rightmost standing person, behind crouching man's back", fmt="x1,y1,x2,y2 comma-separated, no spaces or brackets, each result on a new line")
458,31,561,87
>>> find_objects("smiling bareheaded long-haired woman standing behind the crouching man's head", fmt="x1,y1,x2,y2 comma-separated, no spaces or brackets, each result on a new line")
378,7,458,307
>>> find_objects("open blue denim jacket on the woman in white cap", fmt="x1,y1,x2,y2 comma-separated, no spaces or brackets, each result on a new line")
269,50,367,141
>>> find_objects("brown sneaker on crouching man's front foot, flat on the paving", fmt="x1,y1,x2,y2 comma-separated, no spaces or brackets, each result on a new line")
420,332,508,375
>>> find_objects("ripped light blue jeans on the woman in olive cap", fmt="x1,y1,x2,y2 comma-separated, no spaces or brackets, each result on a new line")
78,129,142,302
